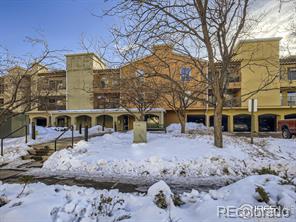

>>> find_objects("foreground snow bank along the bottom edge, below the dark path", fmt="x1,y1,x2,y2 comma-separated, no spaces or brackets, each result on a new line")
0,175,296,222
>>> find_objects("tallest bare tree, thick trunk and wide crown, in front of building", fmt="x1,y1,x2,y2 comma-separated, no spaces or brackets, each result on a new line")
105,0,278,147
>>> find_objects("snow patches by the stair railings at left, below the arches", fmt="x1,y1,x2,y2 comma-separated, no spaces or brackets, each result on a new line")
0,126,111,163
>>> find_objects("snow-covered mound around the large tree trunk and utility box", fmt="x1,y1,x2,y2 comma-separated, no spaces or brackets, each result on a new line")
41,125,296,181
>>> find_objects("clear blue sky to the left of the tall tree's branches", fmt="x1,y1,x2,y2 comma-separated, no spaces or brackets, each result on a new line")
0,0,116,55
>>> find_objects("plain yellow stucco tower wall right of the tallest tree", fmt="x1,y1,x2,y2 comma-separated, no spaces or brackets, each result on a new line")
237,38,281,107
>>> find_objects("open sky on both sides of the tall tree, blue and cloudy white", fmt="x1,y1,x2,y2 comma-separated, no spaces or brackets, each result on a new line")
0,0,296,63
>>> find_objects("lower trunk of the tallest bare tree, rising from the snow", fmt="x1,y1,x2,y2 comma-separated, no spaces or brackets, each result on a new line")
214,98,223,148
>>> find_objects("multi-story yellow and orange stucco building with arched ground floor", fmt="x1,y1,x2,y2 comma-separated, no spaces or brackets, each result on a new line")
0,38,296,132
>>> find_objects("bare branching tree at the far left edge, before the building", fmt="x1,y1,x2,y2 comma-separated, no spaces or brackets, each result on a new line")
0,38,61,125
